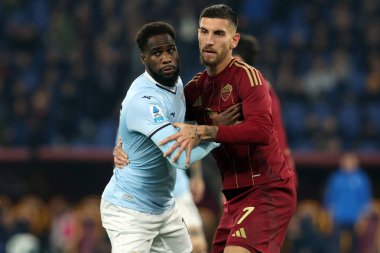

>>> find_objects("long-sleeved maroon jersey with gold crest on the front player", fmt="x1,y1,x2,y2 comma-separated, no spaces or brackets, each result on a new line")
185,59,292,190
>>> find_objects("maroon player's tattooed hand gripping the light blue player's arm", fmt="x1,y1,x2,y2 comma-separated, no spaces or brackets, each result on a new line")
159,122,201,166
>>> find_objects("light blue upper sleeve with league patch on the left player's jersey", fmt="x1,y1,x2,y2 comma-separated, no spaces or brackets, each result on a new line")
125,97,170,137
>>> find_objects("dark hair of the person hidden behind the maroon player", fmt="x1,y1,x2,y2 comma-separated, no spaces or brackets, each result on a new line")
232,34,260,65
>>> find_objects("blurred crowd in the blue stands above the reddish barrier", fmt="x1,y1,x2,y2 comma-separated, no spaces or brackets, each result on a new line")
0,0,380,152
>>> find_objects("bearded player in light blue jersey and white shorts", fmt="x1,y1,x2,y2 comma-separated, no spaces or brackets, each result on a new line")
100,22,218,253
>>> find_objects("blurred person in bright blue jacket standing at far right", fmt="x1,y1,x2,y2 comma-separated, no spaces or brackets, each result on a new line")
323,153,372,253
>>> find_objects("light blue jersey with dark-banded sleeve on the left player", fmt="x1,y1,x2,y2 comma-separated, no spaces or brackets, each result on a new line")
102,72,218,213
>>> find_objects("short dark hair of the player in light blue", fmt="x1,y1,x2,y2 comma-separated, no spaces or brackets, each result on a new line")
136,21,175,52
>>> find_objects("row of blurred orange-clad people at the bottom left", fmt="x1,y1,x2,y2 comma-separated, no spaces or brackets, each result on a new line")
0,195,111,253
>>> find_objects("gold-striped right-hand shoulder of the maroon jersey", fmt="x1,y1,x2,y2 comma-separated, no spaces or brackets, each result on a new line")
229,59,265,86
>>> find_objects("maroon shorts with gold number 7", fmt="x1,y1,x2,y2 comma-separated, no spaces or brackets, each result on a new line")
212,177,297,253
